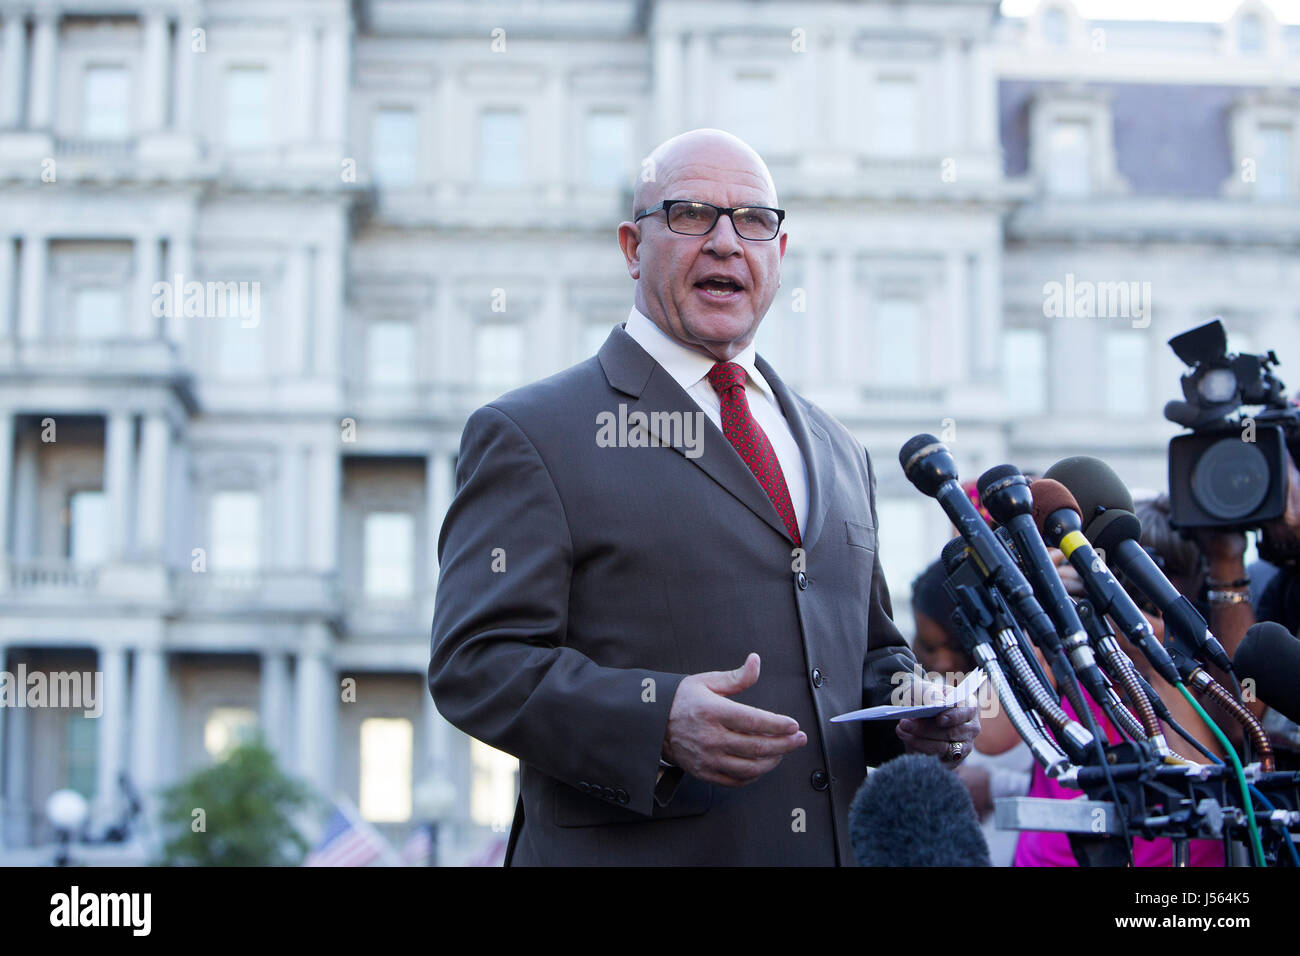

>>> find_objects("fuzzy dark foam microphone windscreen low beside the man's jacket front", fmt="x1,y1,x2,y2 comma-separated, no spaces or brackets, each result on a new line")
849,753,993,866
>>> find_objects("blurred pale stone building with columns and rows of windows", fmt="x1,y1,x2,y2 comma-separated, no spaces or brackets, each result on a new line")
0,0,1300,862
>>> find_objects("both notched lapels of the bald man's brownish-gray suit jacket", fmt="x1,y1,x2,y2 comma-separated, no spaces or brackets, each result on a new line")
597,324,826,550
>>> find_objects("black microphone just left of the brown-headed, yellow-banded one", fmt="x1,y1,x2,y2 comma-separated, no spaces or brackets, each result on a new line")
975,464,1108,702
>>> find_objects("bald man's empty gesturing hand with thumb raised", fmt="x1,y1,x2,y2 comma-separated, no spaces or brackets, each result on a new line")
663,654,809,787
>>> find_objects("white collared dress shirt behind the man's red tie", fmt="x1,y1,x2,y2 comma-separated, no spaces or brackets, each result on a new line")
624,306,809,537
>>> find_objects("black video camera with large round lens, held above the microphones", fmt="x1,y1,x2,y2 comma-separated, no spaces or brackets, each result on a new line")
1165,319,1300,531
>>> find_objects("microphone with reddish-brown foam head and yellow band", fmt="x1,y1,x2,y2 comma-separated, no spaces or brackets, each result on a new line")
1030,477,1182,687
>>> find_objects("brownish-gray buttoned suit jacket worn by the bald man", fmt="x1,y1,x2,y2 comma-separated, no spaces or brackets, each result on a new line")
429,325,915,865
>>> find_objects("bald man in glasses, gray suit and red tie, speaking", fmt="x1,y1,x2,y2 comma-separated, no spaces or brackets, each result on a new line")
429,130,979,865
